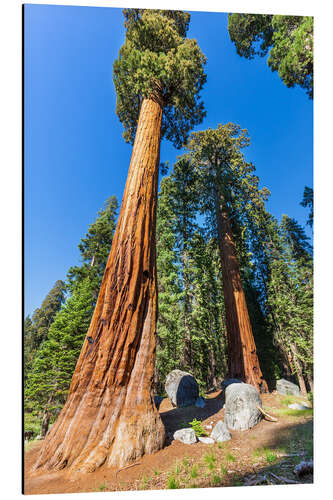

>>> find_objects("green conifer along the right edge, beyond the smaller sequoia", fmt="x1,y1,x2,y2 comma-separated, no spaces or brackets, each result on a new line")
268,216,313,395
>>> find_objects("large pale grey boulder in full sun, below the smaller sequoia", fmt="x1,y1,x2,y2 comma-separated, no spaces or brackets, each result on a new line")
224,383,262,431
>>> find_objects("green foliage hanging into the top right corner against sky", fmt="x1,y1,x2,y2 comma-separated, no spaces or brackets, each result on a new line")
228,14,313,99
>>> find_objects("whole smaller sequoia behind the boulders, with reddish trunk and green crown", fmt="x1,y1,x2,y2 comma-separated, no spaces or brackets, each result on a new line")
187,123,267,392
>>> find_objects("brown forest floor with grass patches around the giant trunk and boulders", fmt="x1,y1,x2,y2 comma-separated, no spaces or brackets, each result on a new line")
24,391,313,494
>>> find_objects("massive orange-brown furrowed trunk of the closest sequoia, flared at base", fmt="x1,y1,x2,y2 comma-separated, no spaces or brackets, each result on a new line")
35,99,165,472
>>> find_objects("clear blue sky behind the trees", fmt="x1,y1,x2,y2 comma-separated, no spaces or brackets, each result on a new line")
24,5,313,314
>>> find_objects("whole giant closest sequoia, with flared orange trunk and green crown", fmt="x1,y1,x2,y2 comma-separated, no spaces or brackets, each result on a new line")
35,10,205,471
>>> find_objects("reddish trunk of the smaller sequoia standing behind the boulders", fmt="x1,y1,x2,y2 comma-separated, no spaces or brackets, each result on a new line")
215,189,268,392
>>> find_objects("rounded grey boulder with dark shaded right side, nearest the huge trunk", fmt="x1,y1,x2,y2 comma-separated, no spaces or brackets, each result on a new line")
165,370,199,407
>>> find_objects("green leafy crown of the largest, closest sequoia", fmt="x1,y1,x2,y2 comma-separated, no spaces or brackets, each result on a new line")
113,9,206,147
